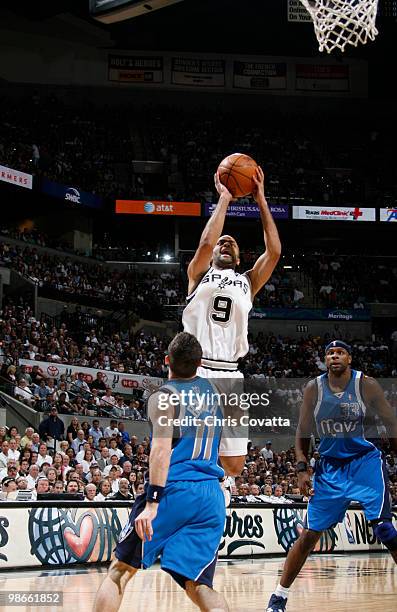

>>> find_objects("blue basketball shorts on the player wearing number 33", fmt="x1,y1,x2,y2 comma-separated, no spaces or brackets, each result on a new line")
305,448,392,531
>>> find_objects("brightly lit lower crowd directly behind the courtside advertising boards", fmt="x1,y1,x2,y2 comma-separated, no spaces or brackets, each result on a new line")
0,420,397,503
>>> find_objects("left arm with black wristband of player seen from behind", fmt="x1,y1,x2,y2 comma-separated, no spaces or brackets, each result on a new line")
135,391,174,540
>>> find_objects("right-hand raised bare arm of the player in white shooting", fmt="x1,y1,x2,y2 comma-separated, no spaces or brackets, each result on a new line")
247,166,281,297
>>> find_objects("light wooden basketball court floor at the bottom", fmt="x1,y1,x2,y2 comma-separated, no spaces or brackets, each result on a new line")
0,553,397,612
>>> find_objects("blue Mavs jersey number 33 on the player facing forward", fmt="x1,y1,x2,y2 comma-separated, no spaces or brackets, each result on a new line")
314,370,374,459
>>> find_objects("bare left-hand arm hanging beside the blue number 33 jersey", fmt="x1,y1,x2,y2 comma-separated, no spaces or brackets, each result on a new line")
295,380,317,495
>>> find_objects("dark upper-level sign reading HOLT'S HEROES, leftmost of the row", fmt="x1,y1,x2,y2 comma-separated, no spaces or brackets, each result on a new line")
108,55,164,85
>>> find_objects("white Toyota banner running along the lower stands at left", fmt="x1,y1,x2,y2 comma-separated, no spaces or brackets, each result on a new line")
19,359,164,394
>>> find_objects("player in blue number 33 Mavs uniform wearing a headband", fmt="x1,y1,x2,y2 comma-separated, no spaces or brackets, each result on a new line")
267,340,397,612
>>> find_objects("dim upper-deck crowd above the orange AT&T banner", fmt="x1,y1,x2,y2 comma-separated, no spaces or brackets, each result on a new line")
0,89,397,205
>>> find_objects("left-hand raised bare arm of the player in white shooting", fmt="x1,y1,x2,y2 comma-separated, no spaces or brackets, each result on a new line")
187,172,233,293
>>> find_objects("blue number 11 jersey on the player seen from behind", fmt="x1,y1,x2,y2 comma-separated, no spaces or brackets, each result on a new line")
155,376,225,484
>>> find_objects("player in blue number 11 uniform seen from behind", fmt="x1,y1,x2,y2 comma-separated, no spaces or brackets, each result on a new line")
94,332,245,612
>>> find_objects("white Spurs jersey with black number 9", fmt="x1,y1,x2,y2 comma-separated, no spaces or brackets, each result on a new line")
182,268,252,370
